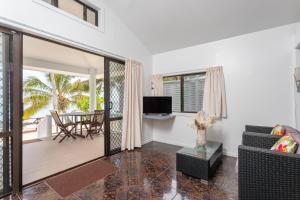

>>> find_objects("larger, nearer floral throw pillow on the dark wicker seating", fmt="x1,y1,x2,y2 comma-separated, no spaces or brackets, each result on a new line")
271,135,297,153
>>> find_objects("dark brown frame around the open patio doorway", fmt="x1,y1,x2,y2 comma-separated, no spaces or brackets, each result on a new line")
0,25,125,198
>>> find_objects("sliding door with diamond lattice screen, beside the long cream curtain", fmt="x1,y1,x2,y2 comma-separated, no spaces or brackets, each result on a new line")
104,58,125,155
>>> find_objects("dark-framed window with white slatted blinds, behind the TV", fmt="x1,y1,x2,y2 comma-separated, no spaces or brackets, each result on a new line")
163,73,205,113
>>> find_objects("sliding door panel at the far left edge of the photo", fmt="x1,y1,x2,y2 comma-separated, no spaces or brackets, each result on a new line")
0,27,22,197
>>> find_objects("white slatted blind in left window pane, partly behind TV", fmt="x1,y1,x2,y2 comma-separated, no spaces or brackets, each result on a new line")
164,80,181,112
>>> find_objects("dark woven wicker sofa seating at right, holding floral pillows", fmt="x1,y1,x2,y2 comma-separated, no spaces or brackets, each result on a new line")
238,126,300,200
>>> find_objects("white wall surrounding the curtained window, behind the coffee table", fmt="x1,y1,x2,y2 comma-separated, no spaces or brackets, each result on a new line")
153,25,295,156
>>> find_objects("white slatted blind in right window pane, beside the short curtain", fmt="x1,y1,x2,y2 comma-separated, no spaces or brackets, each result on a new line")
183,74,205,112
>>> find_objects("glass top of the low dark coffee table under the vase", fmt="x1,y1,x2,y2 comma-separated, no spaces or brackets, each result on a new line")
177,141,222,160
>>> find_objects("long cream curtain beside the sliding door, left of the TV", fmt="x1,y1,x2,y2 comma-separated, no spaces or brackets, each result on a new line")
122,59,143,150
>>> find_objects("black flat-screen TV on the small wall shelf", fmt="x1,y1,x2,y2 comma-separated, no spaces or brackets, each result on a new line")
143,96,172,114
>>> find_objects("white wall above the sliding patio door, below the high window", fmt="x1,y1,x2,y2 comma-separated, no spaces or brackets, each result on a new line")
0,0,152,144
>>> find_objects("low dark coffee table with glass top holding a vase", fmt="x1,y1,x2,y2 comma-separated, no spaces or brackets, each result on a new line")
176,141,223,184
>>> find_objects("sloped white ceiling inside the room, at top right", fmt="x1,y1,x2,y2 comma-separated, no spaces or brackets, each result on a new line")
106,0,300,54
